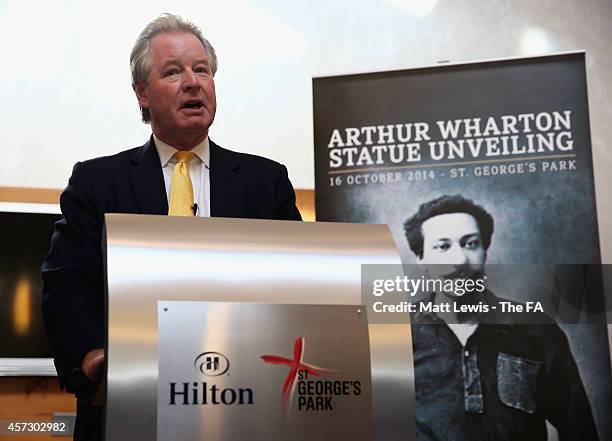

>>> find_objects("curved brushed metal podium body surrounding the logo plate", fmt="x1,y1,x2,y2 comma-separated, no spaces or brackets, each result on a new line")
105,214,414,441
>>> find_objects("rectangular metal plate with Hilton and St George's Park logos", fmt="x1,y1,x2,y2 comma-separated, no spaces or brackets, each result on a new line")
157,301,372,441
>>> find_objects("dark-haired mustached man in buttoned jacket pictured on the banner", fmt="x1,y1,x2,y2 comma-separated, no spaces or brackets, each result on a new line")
404,195,597,441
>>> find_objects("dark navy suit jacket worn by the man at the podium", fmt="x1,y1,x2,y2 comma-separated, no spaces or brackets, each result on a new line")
42,137,301,377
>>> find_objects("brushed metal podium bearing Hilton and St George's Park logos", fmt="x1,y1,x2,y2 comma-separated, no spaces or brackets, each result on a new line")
103,214,415,441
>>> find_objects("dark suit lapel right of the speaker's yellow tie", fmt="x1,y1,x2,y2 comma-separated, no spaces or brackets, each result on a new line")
210,141,246,217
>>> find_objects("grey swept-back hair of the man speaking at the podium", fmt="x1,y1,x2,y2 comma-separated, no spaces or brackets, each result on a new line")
130,14,217,123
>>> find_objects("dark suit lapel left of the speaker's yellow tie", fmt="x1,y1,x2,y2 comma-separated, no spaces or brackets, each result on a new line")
130,137,168,214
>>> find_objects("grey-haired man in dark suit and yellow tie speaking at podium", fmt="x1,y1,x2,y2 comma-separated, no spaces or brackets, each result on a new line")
42,14,301,440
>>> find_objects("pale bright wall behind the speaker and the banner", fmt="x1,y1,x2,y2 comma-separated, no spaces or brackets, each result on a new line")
0,0,612,261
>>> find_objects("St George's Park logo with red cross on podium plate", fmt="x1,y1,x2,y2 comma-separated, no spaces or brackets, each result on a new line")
261,337,361,416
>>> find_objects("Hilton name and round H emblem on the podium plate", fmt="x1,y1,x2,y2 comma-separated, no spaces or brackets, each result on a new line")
168,352,253,406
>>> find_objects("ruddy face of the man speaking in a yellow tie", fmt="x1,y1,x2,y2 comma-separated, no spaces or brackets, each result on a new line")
136,32,217,148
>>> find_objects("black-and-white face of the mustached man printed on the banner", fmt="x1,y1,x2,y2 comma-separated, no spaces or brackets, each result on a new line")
419,213,487,278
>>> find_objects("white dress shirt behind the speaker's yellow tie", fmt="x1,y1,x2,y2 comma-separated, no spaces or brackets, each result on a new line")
153,135,210,217
